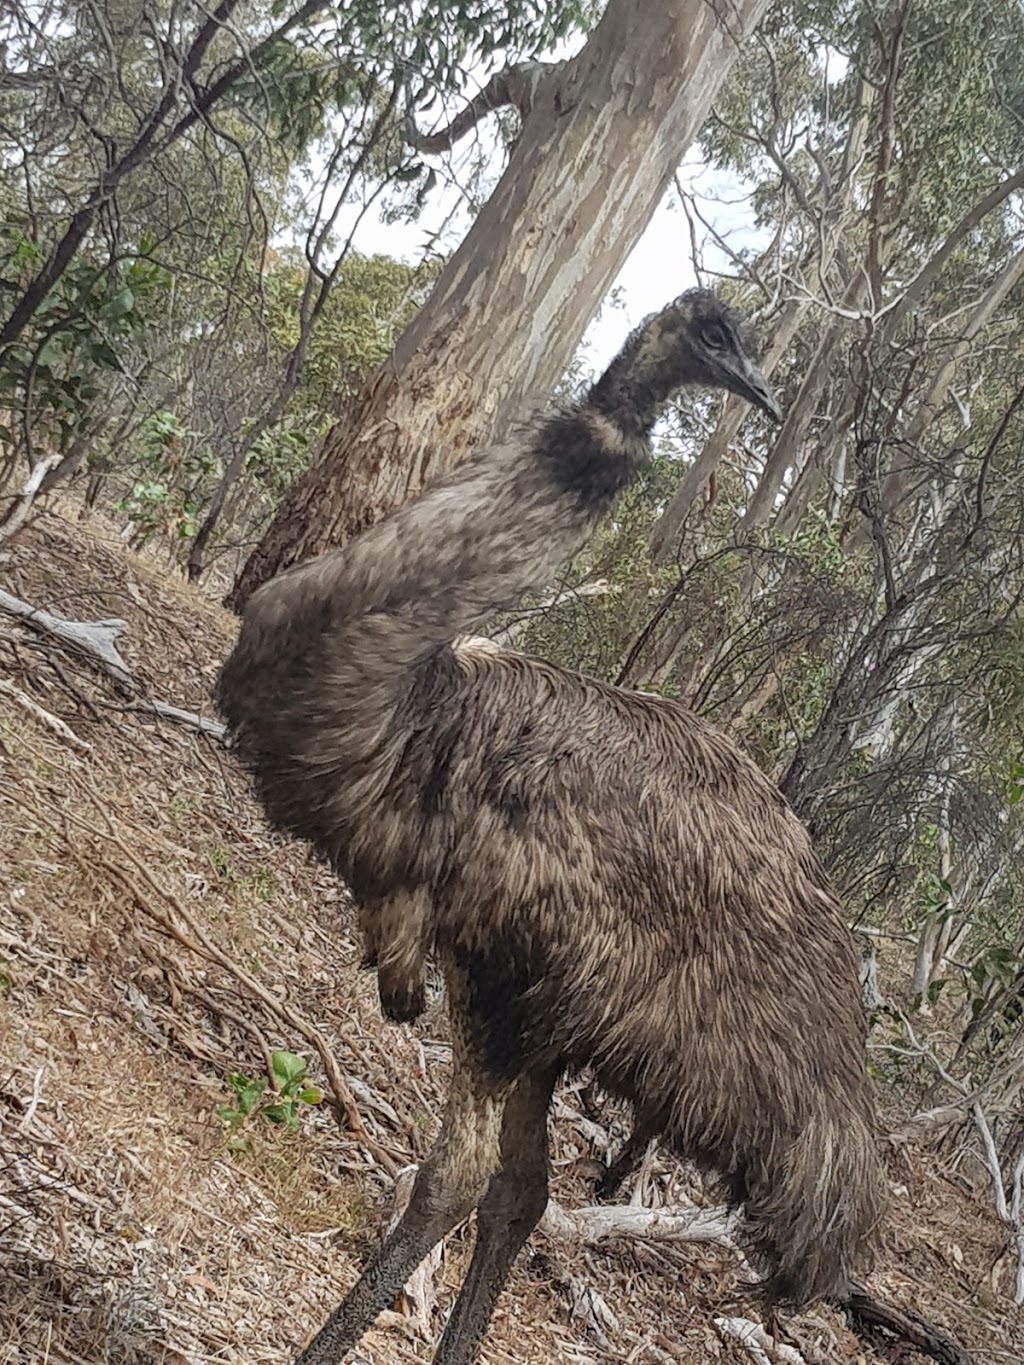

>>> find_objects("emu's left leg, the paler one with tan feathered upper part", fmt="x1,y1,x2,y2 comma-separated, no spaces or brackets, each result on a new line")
295,1047,509,1365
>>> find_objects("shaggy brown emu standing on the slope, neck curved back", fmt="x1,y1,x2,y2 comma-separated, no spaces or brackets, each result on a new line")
217,291,881,1365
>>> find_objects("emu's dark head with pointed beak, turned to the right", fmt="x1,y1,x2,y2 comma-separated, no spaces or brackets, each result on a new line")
635,289,782,422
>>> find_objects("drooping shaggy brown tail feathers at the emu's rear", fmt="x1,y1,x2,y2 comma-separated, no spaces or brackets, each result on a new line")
747,1110,882,1306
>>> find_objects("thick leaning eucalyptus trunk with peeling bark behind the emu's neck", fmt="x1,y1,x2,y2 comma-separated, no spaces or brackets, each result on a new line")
228,0,767,610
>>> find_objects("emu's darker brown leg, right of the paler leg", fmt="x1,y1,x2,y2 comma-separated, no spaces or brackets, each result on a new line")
434,1073,556,1365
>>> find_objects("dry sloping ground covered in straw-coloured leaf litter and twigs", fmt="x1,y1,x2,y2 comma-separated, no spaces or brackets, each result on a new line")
0,512,1024,1365
